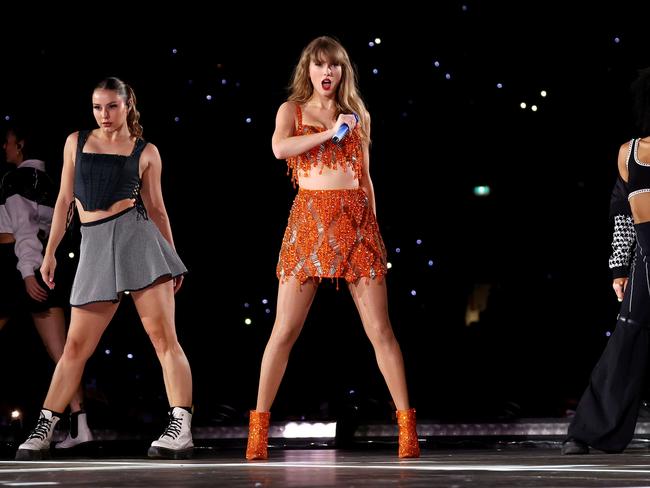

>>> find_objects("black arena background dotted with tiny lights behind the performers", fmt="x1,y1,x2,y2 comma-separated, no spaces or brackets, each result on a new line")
0,2,650,428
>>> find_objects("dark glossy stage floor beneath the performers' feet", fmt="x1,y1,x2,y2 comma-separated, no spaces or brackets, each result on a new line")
0,447,650,487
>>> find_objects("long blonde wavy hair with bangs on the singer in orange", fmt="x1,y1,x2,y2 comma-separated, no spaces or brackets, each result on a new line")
287,36,370,143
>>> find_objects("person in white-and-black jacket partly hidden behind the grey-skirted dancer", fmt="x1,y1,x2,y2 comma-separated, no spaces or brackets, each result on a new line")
0,125,93,449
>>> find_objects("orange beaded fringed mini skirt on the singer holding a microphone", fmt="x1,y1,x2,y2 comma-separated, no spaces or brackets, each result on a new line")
277,188,386,283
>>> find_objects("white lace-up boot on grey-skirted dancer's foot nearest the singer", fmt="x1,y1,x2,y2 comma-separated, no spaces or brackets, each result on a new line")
147,407,194,459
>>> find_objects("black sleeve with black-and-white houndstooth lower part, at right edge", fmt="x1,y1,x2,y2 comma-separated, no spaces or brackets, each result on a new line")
609,176,636,278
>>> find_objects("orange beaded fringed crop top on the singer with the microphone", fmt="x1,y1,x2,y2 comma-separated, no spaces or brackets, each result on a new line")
287,105,363,185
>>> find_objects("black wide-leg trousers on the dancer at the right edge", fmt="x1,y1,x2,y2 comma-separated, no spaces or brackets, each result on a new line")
568,222,650,452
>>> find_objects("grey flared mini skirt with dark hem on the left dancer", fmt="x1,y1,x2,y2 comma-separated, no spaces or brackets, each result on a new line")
70,207,187,307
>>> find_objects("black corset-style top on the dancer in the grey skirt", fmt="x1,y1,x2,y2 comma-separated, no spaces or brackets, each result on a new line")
74,130,147,211
